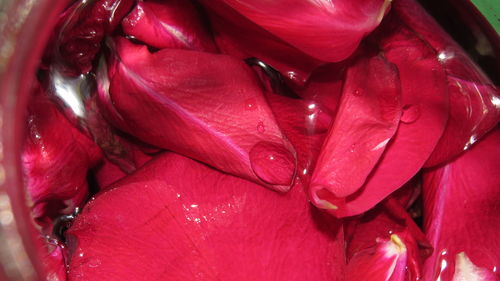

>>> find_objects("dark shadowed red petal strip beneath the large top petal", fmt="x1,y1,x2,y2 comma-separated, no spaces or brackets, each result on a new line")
203,1,323,86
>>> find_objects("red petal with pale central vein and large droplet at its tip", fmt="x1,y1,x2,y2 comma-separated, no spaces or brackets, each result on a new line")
101,39,296,191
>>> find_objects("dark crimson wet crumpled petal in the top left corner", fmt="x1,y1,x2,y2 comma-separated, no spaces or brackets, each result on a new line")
46,0,134,75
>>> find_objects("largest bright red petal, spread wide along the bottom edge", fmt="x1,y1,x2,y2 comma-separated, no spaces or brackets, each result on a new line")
67,153,344,281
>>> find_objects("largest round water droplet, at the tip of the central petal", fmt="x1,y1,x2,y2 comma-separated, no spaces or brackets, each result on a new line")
250,141,296,185
